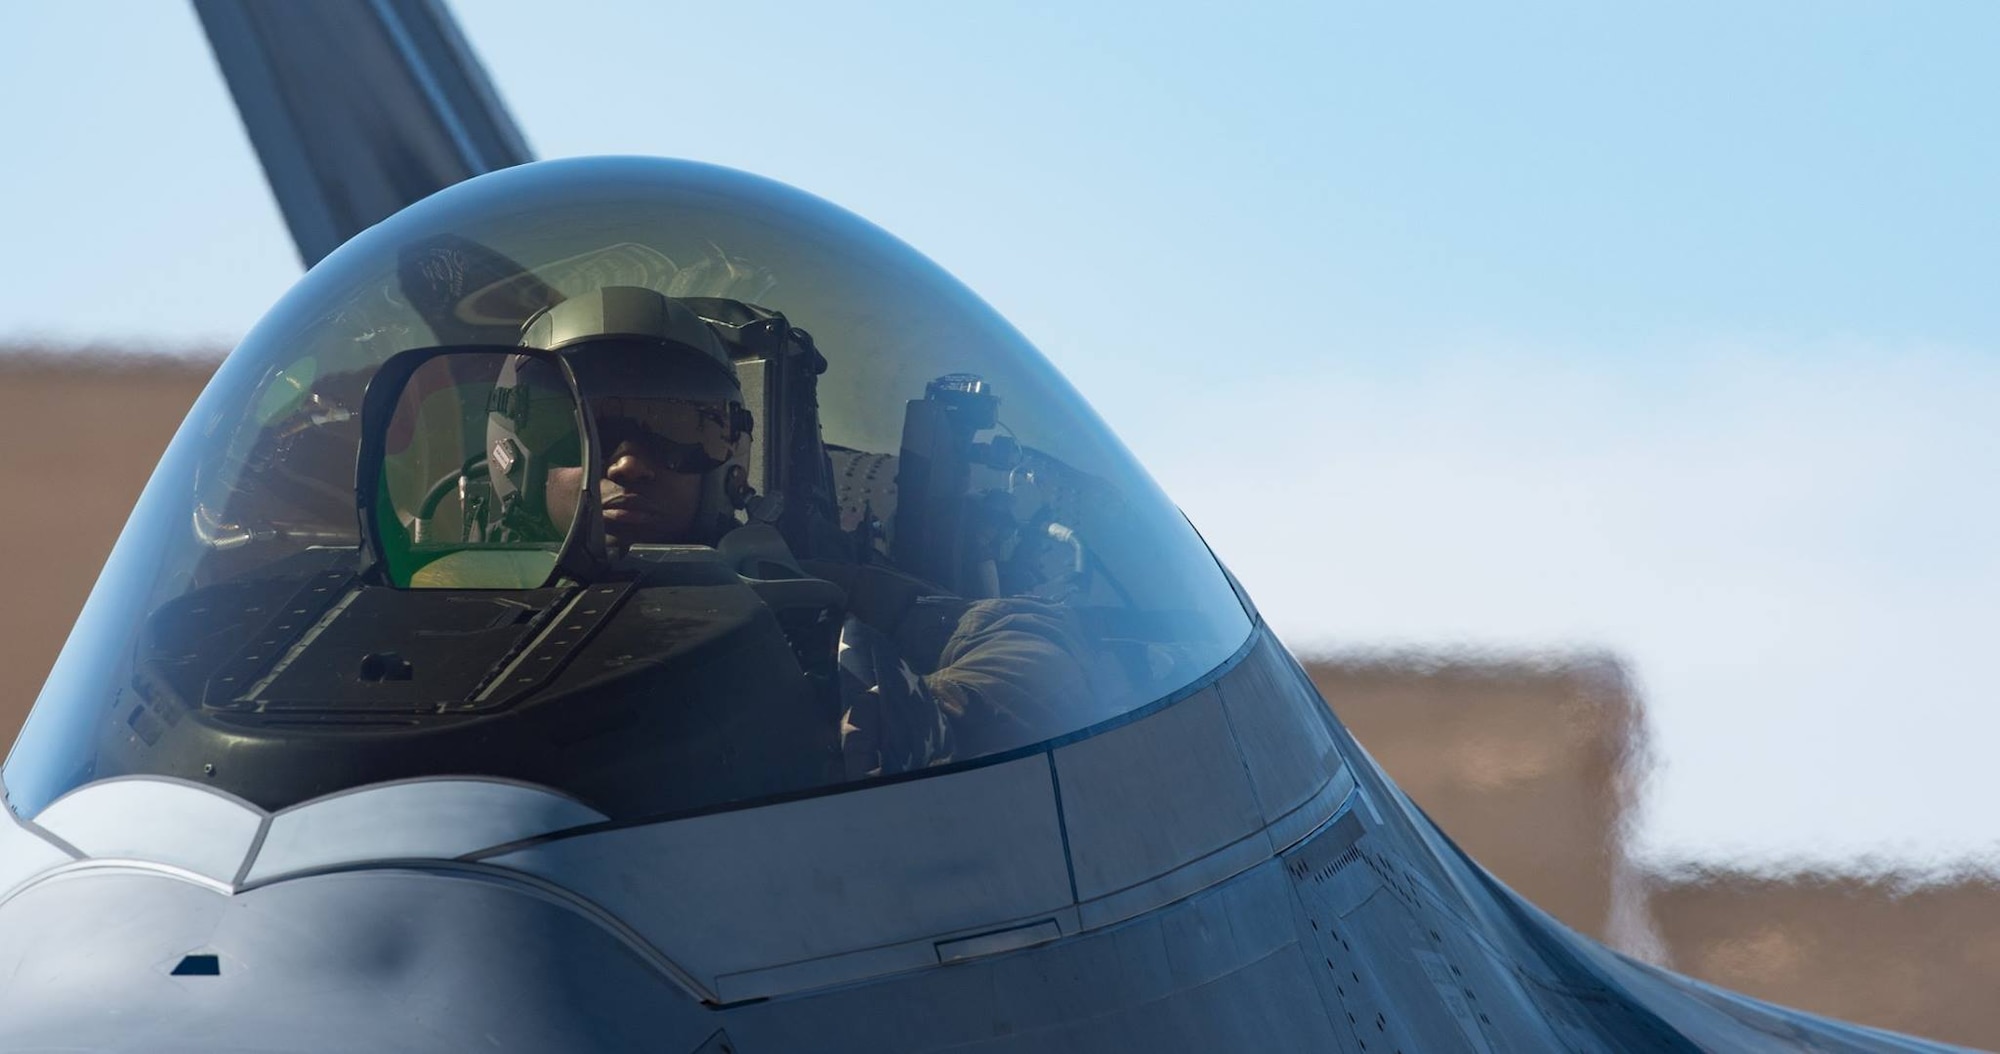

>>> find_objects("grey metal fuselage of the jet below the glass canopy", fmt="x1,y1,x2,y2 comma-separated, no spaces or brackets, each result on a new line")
0,642,1968,1054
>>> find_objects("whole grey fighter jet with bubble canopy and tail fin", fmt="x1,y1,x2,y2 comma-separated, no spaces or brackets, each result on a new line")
0,0,1968,1054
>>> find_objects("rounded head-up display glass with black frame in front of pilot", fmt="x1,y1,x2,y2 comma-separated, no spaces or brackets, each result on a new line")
356,348,596,590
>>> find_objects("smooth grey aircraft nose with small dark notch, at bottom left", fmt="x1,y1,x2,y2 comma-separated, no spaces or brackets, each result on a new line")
0,866,716,1052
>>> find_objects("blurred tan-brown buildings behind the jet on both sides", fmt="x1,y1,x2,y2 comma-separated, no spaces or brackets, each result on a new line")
0,346,2000,1048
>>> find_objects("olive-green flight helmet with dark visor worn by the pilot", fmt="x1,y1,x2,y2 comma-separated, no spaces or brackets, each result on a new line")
520,286,754,544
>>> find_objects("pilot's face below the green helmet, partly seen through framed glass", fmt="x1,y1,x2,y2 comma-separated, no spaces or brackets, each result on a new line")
548,414,702,548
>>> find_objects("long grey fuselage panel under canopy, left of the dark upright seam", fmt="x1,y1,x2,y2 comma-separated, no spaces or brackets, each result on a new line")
488,756,1074,1002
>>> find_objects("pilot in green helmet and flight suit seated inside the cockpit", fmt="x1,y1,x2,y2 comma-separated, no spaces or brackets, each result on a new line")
522,286,1092,778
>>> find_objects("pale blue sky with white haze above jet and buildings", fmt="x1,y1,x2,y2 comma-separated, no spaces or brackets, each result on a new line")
0,0,2000,876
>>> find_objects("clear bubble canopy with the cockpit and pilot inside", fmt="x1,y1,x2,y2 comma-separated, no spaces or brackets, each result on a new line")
4,158,1250,820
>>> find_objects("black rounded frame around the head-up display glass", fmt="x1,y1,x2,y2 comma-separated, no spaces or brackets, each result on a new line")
354,344,606,588
